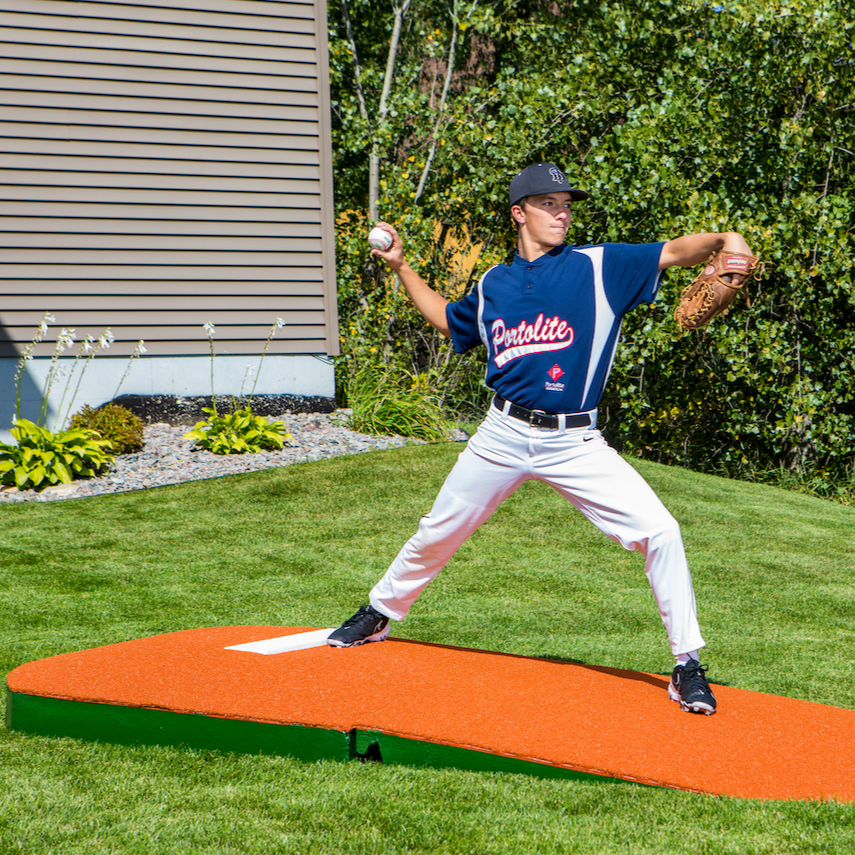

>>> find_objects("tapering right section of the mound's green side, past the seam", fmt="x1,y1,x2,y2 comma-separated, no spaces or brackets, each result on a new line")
355,730,640,784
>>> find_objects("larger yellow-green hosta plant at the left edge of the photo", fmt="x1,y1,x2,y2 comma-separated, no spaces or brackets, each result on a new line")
0,419,113,490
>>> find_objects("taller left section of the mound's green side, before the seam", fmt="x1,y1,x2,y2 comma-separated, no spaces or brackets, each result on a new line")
6,689,354,762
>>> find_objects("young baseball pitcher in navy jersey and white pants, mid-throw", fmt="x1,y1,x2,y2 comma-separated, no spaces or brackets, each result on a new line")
328,163,750,715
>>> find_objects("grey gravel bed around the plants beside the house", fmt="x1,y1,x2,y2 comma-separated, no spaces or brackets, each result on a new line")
0,410,442,502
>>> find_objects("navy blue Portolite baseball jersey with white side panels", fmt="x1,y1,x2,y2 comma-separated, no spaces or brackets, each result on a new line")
446,243,664,413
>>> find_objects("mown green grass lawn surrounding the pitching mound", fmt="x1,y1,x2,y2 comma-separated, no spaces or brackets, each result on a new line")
0,444,855,855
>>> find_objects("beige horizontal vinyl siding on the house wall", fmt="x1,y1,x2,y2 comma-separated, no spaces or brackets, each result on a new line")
0,0,338,356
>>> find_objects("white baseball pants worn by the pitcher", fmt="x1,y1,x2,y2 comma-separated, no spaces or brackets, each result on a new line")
371,406,704,656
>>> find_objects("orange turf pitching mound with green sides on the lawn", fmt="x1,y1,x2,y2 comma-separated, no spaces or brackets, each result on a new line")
7,626,855,802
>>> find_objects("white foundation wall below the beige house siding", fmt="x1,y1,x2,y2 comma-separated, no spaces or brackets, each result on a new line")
0,354,335,443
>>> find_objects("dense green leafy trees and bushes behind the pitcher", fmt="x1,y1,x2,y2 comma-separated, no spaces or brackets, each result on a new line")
329,0,855,493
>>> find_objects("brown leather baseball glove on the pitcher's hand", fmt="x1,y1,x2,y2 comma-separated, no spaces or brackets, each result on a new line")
674,250,760,330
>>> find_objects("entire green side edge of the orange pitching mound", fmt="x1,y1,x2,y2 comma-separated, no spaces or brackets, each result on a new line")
6,689,648,783
